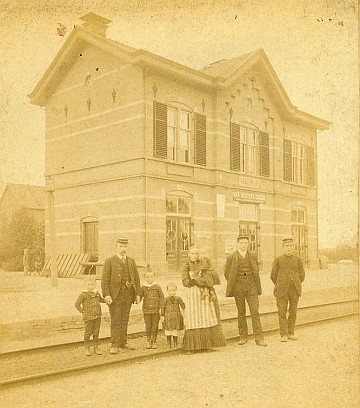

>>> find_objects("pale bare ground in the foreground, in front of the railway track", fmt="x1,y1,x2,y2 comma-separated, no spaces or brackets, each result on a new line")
0,317,360,408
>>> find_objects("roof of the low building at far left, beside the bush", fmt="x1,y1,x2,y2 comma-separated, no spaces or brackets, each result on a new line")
0,183,46,210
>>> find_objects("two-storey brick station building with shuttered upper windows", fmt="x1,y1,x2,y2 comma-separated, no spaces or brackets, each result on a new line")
29,13,330,272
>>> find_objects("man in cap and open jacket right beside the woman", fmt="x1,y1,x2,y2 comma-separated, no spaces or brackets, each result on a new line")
225,235,266,346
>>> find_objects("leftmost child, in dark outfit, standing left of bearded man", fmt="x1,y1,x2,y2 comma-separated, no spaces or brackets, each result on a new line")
75,276,105,356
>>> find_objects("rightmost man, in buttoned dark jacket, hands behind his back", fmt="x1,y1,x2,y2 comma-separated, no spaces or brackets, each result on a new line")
270,238,305,342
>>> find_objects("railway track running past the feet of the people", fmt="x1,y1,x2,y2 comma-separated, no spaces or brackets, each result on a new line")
0,299,358,388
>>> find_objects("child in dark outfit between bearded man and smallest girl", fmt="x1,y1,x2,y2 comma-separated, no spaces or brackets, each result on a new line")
141,268,164,349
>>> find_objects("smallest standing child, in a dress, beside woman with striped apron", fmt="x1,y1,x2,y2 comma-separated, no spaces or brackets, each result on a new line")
163,282,185,348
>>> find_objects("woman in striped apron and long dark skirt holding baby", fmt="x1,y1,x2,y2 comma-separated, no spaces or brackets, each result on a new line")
182,247,226,351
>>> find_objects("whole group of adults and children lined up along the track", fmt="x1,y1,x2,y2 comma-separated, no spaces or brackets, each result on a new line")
75,235,305,355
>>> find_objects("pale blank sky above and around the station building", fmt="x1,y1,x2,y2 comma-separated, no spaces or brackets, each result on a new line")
0,0,359,247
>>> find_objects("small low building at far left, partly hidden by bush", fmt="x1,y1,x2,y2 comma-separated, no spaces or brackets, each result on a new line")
0,183,46,228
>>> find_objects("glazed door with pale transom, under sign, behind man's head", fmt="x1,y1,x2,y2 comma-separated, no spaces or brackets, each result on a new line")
239,203,259,252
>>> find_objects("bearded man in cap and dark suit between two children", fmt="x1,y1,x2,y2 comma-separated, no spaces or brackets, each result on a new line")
101,238,140,354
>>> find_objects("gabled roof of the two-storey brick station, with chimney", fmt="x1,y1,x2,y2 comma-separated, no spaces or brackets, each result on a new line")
29,14,331,130
